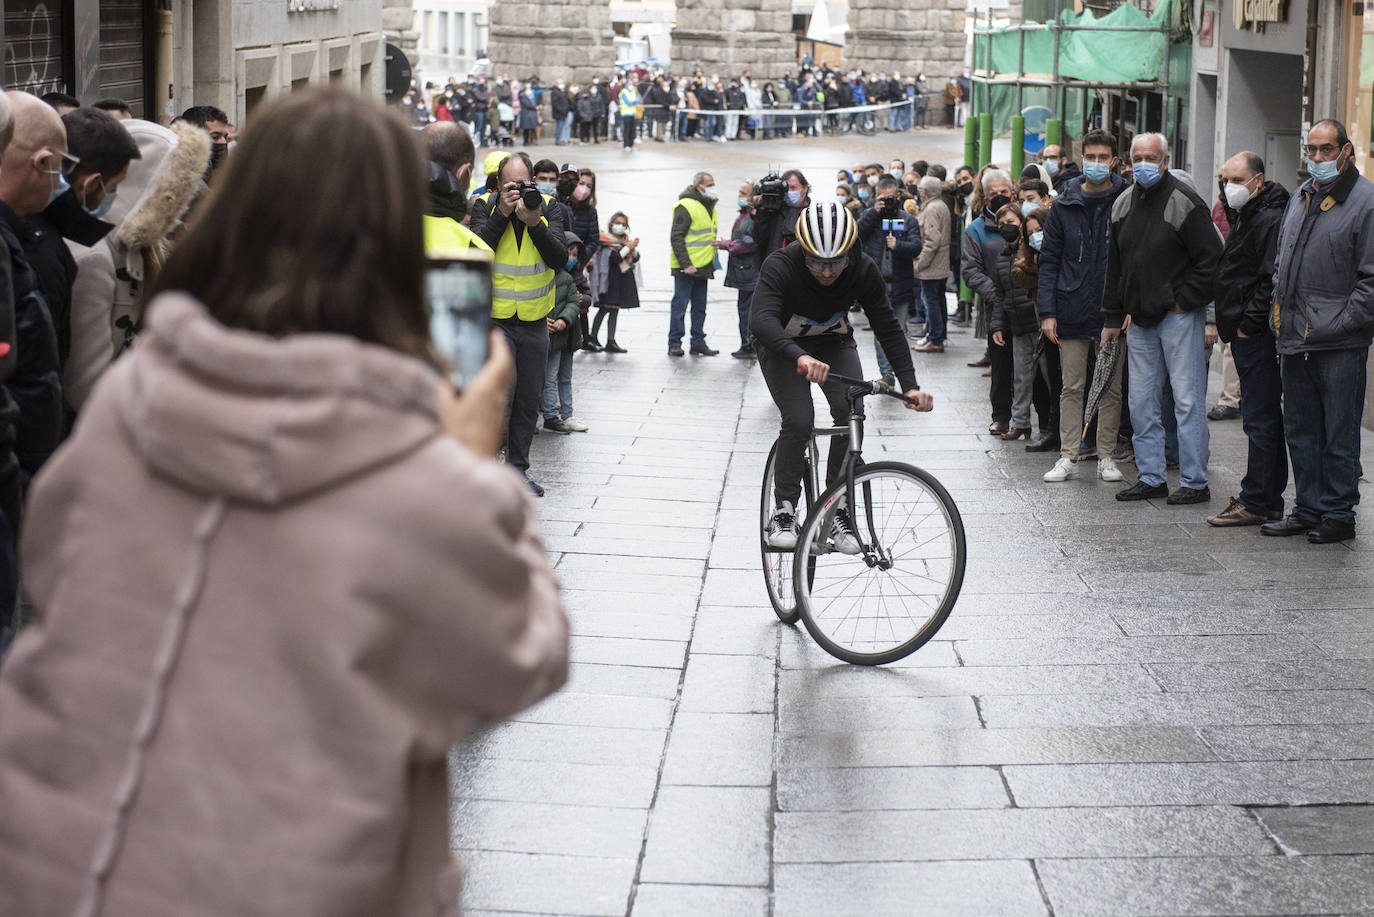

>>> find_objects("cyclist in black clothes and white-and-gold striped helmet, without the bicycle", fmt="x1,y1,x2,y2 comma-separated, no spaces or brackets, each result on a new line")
749,201,934,554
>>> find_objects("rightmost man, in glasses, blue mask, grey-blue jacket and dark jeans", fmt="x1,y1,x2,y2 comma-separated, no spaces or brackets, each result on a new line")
1260,120,1374,544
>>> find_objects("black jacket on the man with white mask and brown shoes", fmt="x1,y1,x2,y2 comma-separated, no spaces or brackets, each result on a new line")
1215,181,1289,342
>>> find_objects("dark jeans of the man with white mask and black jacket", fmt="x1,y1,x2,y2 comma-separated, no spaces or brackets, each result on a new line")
1231,331,1286,516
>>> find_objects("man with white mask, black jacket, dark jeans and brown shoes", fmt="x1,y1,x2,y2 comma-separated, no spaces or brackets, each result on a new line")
1208,153,1289,525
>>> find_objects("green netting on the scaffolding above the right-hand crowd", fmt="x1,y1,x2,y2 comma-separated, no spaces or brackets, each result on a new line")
973,0,1193,137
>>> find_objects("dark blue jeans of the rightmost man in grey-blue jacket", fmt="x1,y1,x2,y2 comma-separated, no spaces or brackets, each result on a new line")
1275,346,1369,525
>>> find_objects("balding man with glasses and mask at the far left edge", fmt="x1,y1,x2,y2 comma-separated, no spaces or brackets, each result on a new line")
0,92,77,481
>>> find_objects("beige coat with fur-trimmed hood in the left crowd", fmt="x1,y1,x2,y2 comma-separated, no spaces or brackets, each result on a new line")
63,120,210,412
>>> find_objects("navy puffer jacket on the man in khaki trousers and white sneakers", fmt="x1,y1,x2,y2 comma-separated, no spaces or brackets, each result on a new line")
1039,175,1129,341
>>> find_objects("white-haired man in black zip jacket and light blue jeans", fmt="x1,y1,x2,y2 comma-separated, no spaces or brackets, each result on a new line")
1102,133,1221,506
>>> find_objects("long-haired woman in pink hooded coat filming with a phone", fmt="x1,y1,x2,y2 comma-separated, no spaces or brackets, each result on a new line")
0,91,567,917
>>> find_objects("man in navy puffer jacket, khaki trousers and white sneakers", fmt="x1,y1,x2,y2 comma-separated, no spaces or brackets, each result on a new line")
1037,131,1127,484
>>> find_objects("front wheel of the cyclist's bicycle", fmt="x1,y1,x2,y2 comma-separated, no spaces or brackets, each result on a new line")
793,462,967,665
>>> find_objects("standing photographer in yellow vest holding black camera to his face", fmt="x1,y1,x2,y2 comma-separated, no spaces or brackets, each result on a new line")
473,153,567,496
